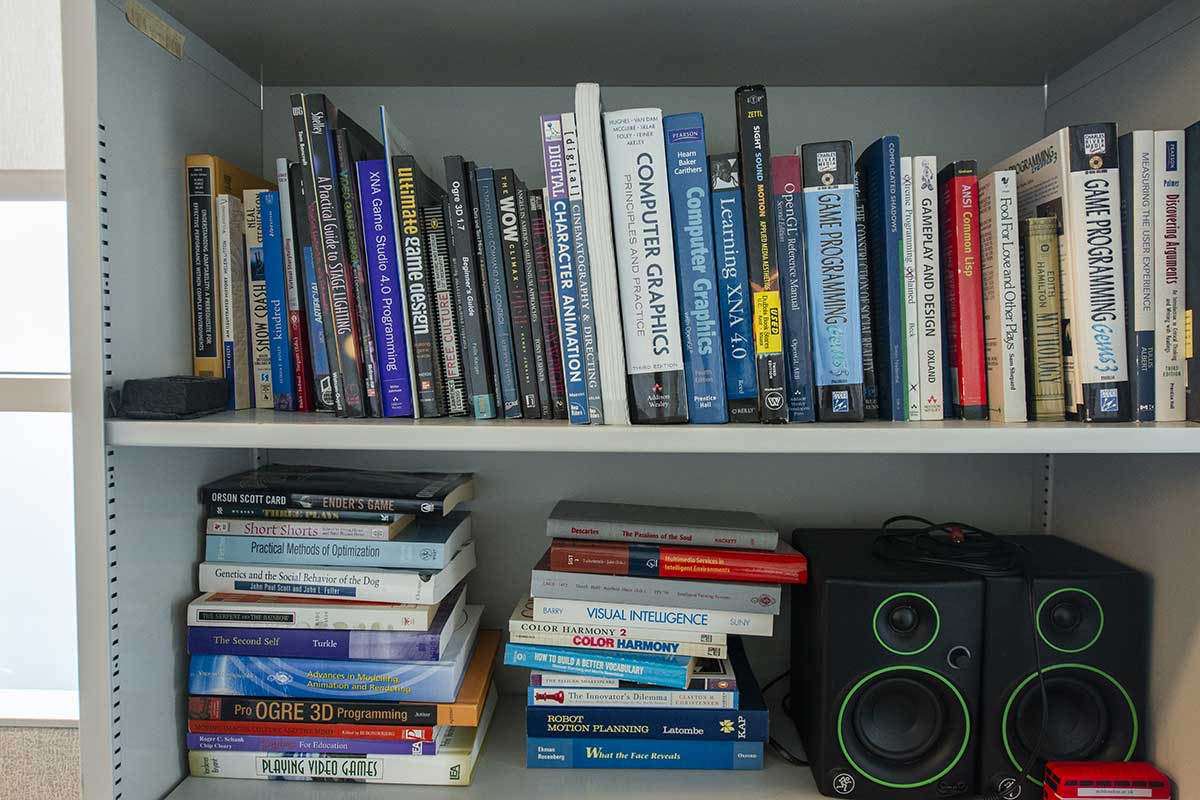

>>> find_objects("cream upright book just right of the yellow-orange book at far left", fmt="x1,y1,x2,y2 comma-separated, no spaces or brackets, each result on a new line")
217,194,254,410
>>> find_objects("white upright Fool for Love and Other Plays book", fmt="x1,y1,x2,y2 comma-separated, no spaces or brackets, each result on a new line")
979,169,1028,422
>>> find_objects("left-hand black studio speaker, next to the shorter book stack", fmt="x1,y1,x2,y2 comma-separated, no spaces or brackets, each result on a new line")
791,530,984,800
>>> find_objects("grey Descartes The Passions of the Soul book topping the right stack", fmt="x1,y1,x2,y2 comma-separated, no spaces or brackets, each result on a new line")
546,500,779,551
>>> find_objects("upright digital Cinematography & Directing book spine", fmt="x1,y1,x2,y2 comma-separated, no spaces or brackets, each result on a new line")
562,112,608,425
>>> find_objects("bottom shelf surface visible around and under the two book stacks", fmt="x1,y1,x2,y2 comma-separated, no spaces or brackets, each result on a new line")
167,696,821,800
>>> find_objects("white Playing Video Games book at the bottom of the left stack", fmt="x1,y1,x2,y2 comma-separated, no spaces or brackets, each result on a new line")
187,688,499,786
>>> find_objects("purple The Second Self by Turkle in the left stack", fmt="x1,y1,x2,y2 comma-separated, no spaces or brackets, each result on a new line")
187,626,442,661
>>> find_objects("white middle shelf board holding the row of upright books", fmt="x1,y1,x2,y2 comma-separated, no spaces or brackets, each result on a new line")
106,410,1200,453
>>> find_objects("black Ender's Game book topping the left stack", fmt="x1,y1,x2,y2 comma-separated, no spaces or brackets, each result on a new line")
200,464,475,515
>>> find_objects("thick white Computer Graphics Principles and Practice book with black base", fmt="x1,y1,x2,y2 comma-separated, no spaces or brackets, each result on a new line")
604,108,688,423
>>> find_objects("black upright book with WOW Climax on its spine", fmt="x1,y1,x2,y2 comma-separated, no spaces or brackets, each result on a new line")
496,169,541,420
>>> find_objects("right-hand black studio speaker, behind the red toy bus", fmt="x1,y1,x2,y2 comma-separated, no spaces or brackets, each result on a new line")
979,536,1150,798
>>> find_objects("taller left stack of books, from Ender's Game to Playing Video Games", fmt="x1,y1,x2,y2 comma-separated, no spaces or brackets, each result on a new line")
186,464,500,784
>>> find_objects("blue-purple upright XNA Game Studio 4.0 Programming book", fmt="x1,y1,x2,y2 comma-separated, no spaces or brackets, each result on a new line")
358,158,413,416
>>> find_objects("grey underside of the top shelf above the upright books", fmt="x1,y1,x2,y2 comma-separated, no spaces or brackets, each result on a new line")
147,0,1168,86
